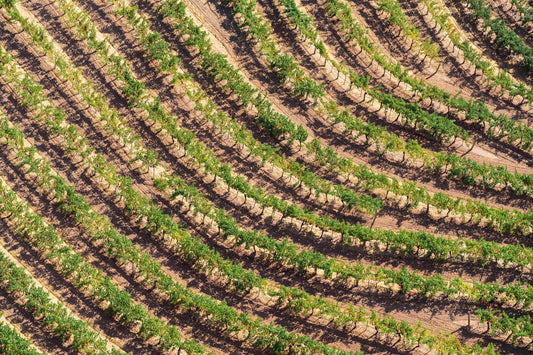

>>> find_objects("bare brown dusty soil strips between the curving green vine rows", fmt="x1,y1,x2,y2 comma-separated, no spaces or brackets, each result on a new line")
0,0,533,353
